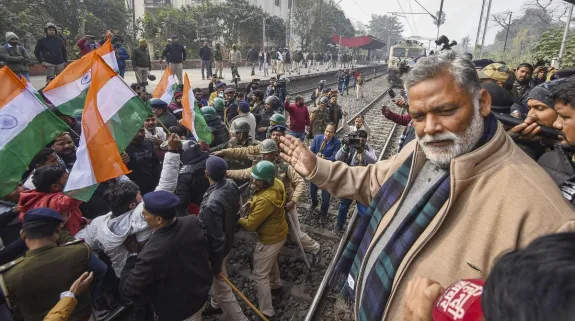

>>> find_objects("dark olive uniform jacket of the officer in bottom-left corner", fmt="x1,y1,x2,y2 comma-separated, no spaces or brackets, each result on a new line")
0,240,92,321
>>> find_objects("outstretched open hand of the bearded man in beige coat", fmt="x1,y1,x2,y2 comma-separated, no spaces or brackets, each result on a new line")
280,135,317,177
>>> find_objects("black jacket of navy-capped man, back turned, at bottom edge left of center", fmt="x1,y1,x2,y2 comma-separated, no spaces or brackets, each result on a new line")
120,215,213,321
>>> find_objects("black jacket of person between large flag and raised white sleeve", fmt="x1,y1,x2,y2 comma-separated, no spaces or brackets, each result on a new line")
126,138,160,195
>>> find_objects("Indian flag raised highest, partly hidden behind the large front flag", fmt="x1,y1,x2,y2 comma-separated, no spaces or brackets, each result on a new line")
43,38,119,116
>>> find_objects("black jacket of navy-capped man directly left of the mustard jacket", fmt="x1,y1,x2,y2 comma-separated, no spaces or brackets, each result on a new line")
200,179,241,275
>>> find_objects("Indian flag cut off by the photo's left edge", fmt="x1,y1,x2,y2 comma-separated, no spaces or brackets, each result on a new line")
0,67,69,197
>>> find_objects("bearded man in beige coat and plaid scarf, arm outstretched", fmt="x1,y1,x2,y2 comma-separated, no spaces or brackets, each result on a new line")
281,51,575,321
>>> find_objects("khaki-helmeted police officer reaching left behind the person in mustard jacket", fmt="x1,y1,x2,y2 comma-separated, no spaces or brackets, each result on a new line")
226,139,320,260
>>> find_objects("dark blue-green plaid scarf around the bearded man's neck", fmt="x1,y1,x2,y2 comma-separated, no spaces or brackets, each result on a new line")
330,114,497,321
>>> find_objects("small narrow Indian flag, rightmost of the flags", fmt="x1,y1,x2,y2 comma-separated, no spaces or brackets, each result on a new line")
182,73,212,145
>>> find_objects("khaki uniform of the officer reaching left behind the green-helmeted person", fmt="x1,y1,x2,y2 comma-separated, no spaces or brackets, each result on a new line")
226,158,320,254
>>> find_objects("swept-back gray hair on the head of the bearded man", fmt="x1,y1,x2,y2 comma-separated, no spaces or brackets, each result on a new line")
404,50,481,97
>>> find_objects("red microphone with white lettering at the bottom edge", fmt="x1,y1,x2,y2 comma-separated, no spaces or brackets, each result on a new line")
432,279,485,321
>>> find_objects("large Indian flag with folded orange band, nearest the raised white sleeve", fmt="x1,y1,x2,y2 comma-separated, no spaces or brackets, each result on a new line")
64,55,151,201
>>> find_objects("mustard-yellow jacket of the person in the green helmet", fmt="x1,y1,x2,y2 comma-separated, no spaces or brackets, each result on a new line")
239,178,288,245
